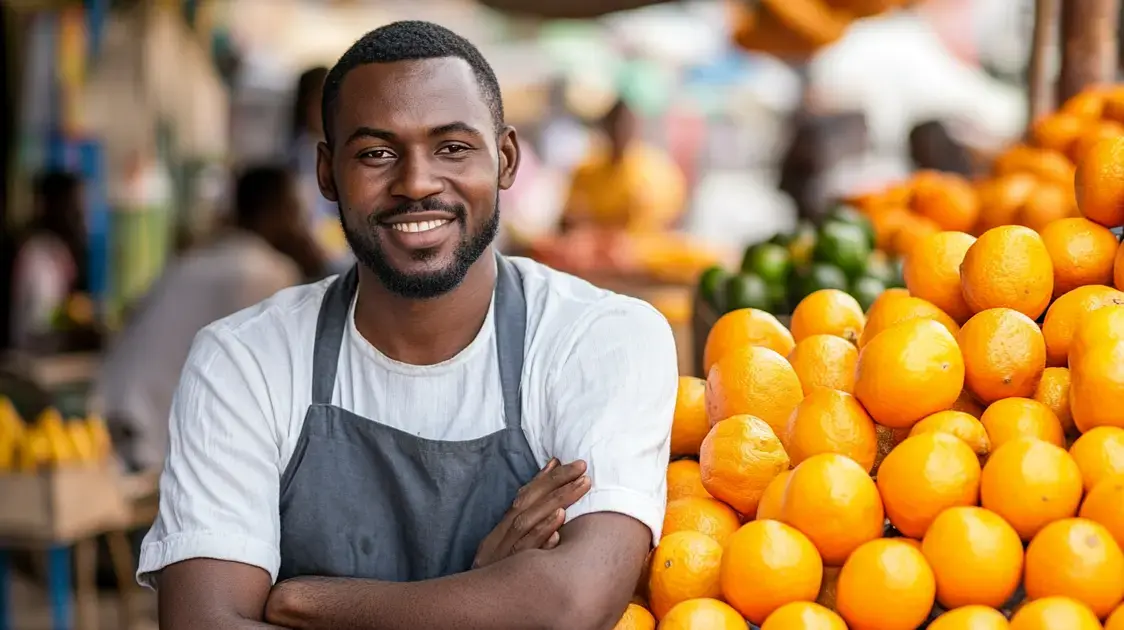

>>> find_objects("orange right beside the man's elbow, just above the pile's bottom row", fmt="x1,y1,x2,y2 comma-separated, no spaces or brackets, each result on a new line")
647,531,722,619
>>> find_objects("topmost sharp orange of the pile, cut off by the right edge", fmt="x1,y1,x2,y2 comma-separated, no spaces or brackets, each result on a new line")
1073,137,1124,227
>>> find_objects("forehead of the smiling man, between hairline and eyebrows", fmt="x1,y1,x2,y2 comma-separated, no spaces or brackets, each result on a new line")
335,57,491,137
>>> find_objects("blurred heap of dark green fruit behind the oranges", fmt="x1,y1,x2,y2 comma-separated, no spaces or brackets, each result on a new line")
699,206,901,314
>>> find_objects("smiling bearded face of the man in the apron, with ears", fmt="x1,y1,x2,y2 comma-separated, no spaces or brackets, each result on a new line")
318,57,518,298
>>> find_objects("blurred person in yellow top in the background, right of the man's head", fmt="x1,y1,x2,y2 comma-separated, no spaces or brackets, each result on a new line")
562,101,687,231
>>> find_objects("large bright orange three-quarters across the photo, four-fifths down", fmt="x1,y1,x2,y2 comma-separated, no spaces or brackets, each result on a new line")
781,453,885,566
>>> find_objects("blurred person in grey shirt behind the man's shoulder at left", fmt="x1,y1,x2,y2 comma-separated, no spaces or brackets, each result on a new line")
97,167,323,470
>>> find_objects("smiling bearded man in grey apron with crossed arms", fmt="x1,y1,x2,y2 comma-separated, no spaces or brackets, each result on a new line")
138,21,677,630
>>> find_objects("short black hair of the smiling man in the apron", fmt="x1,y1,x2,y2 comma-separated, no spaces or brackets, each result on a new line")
320,20,504,144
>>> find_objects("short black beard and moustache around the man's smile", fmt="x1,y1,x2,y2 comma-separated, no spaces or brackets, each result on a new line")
336,191,499,299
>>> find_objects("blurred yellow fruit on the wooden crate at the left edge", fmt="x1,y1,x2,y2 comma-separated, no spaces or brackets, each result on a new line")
0,397,111,474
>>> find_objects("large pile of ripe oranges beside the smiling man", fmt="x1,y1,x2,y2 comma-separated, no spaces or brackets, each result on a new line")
617,92,1124,630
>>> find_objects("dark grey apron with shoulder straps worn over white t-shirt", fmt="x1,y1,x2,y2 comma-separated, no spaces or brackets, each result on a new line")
278,257,538,582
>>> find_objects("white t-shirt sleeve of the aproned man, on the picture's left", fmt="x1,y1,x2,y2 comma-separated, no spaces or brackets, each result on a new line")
137,326,281,587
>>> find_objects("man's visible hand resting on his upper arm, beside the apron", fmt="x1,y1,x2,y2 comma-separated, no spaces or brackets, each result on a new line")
472,458,590,568
